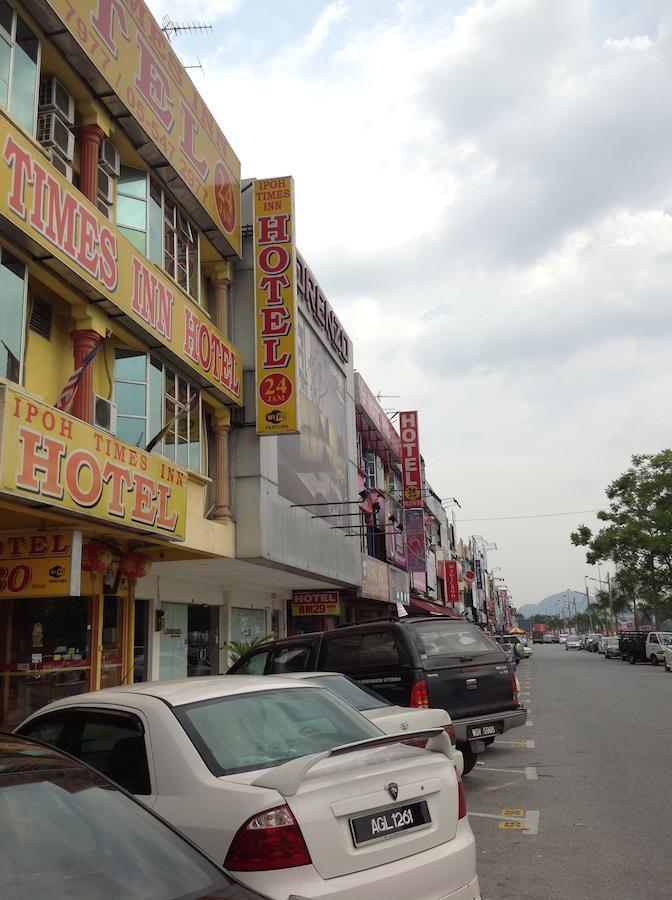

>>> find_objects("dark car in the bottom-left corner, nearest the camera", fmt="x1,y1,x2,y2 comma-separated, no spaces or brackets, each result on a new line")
0,734,262,900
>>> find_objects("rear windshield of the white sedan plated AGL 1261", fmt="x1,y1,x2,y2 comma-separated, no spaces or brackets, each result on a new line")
174,688,383,775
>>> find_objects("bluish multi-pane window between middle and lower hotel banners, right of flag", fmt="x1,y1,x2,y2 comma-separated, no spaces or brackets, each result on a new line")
114,350,204,472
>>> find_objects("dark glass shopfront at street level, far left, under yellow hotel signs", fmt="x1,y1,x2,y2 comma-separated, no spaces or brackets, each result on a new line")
0,597,91,731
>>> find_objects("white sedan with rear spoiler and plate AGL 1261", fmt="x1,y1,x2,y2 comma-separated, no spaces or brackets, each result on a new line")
17,675,480,900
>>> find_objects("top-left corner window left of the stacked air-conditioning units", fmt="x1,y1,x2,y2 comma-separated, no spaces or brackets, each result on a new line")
0,0,40,135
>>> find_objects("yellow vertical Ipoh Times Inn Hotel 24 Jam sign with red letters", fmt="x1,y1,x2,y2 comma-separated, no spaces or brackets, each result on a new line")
254,176,300,435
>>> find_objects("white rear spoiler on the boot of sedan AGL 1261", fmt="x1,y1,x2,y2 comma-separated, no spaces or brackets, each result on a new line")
252,728,452,797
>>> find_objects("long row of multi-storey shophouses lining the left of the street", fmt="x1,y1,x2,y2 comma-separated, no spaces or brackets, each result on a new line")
0,0,506,728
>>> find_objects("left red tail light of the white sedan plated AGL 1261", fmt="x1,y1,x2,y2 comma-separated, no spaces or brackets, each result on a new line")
224,806,311,872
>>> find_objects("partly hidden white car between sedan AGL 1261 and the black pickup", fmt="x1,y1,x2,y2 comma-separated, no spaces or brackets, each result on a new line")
276,672,464,775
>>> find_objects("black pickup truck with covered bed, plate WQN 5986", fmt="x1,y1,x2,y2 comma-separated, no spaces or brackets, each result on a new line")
229,616,527,773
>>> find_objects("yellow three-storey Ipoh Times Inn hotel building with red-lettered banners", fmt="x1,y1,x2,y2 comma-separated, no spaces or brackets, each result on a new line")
0,0,245,729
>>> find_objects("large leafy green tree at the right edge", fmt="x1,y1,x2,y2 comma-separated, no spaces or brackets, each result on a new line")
570,450,672,624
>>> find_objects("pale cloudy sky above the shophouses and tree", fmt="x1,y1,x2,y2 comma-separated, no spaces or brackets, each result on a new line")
149,0,672,606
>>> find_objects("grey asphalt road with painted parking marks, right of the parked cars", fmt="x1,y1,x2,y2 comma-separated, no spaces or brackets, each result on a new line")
465,645,672,900
